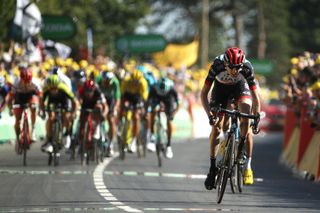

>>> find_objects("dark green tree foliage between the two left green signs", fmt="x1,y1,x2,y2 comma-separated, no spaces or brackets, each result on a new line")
38,0,149,58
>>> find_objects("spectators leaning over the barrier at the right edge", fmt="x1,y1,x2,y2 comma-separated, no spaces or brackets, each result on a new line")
280,51,320,130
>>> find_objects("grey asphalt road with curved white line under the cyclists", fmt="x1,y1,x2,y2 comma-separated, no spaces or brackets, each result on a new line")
0,134,320,212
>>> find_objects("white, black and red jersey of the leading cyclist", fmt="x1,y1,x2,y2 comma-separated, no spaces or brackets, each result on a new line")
205,54,257,90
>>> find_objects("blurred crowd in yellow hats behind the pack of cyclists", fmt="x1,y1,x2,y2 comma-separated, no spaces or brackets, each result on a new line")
0,40,207,137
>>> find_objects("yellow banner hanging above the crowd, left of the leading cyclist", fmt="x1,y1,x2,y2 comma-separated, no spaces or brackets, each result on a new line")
152,39,199,69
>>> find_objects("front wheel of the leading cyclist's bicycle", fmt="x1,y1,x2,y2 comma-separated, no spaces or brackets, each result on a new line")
217,135,234,203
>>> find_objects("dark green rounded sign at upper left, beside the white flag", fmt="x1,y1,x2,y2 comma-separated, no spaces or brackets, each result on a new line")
41,15,77,40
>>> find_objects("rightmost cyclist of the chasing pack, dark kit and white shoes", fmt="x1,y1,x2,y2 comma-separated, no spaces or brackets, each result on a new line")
148,77,179,159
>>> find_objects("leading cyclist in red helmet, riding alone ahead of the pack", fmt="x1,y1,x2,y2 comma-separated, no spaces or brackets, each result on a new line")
201,47,261,190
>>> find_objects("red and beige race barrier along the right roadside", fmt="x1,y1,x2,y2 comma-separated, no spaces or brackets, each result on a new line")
282,107,320,181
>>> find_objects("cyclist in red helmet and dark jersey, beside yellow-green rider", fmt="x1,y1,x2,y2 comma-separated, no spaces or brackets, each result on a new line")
79,79,108,149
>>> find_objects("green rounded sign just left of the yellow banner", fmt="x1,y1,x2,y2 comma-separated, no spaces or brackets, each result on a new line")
116,34,167,53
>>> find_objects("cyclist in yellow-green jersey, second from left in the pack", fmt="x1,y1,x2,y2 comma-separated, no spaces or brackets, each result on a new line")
40,74,77,152
